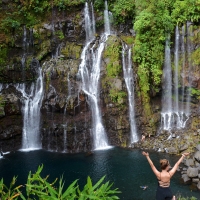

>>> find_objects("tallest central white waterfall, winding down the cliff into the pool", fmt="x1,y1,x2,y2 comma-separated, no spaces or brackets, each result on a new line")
79,2,108,149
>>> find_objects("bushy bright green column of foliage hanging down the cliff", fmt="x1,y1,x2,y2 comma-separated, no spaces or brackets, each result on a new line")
133,0,177,113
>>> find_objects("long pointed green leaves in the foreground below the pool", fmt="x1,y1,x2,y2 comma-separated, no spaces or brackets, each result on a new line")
0,165,120,200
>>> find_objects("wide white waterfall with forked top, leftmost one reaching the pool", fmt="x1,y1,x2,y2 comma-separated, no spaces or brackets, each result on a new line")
16,60,43,150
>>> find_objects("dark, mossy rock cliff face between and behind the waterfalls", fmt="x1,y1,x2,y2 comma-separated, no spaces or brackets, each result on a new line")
0,2,200,153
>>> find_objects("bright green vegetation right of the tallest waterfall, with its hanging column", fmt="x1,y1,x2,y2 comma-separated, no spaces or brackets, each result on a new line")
109,0,200,115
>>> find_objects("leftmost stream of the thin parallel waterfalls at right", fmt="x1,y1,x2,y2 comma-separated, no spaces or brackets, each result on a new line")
161,36,172,130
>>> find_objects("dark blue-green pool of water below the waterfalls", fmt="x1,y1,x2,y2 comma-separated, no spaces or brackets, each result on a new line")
0,148,200,200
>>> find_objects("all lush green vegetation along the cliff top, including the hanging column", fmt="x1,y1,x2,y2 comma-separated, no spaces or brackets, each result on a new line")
0,0,200,103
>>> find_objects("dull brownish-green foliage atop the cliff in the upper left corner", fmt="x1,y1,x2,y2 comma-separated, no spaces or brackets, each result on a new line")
1,0,85,33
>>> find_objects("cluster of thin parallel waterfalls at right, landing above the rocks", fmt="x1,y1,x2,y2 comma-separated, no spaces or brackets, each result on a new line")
161,26,190,130
